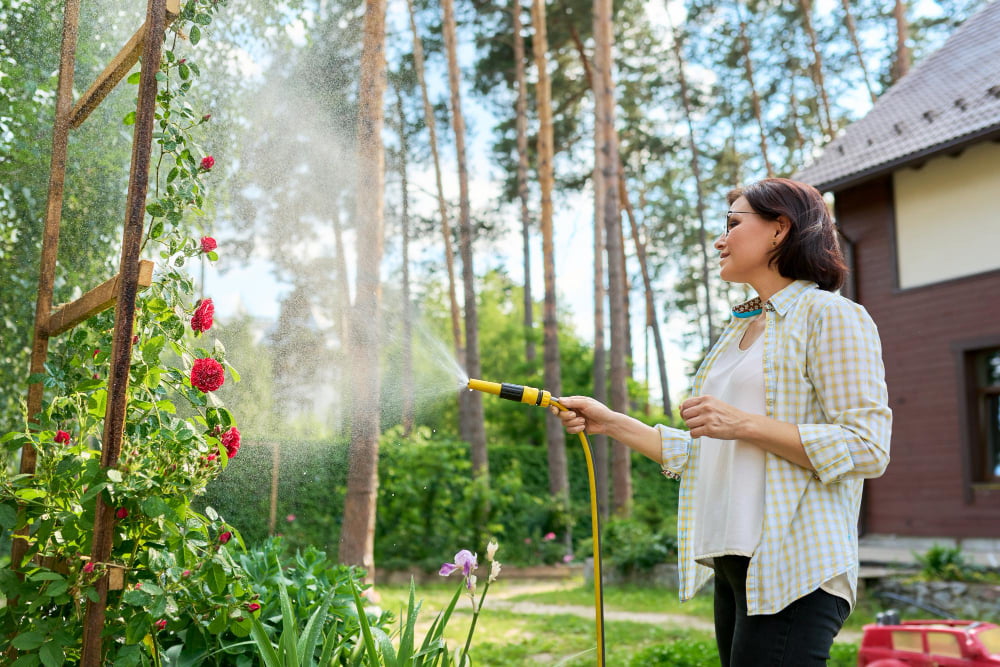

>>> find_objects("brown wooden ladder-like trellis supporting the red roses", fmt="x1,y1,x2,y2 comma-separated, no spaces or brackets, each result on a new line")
11,0,180,667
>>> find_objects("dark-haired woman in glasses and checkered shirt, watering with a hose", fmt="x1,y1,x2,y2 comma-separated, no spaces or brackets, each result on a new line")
559,178,892,667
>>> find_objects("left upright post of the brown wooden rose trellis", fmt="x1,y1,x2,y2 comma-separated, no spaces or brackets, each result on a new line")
10,0,80,569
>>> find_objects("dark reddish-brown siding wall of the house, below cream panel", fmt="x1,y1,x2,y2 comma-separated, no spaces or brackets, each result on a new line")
836,178,1000,538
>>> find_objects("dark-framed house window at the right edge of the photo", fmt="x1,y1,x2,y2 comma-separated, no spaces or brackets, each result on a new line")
972,348,1000,482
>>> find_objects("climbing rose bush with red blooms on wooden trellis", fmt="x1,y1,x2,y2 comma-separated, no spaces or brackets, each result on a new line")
0,0,248,665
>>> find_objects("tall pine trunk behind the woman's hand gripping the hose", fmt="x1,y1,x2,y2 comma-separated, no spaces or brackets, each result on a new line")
531,0,569,502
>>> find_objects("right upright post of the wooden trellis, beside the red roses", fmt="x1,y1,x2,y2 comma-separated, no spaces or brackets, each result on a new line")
80,0,166,667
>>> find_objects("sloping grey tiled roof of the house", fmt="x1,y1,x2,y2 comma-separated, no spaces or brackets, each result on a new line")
794,0,1000,190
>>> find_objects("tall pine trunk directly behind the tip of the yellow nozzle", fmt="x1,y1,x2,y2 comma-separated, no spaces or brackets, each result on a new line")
441,0,490,479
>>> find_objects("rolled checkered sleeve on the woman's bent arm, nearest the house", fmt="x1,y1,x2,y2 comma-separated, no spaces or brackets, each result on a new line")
796,301,892,483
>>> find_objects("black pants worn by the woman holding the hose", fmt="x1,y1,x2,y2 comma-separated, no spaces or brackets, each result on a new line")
715,556,850,667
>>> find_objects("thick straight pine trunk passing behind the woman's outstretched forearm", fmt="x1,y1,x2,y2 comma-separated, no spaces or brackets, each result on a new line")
593,0,632,516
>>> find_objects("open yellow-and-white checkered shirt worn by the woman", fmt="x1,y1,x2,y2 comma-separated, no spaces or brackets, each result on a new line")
657,280,892,615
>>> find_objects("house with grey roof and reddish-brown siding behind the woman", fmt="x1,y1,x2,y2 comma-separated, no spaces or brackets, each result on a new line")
795,1,1000,548
